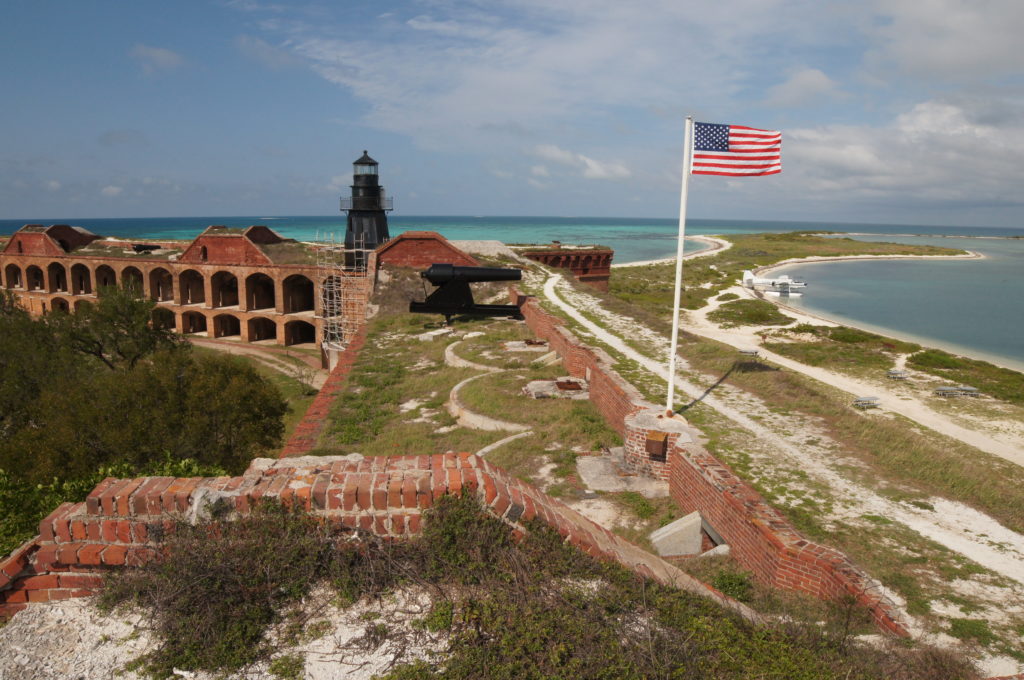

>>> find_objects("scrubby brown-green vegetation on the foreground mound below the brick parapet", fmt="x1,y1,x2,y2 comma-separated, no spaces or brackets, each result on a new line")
102,497,976,680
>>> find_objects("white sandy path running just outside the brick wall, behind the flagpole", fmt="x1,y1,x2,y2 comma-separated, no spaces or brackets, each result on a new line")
544,274,1024,597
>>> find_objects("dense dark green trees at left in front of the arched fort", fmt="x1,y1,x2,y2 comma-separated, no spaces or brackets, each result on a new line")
0,289,287,554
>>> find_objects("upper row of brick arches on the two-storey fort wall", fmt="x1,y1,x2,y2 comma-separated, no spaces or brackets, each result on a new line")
2,262,315,314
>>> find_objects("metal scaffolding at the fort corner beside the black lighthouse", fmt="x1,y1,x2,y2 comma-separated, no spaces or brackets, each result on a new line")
316,231,370,353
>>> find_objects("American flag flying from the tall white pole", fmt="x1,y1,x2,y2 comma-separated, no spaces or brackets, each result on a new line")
692,123,782,176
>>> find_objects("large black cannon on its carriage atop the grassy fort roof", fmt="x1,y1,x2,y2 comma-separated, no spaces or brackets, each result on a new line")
409,264,522,324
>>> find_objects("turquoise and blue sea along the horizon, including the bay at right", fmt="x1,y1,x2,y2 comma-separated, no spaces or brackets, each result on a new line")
0,214,1024,370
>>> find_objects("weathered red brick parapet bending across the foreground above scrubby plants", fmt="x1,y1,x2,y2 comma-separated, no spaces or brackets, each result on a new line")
0,454,756,618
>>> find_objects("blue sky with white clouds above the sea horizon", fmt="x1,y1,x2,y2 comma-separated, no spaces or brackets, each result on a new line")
0,0,1024,226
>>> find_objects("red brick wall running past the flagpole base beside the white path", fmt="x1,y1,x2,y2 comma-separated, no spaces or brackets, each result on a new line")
511,291,909,637
